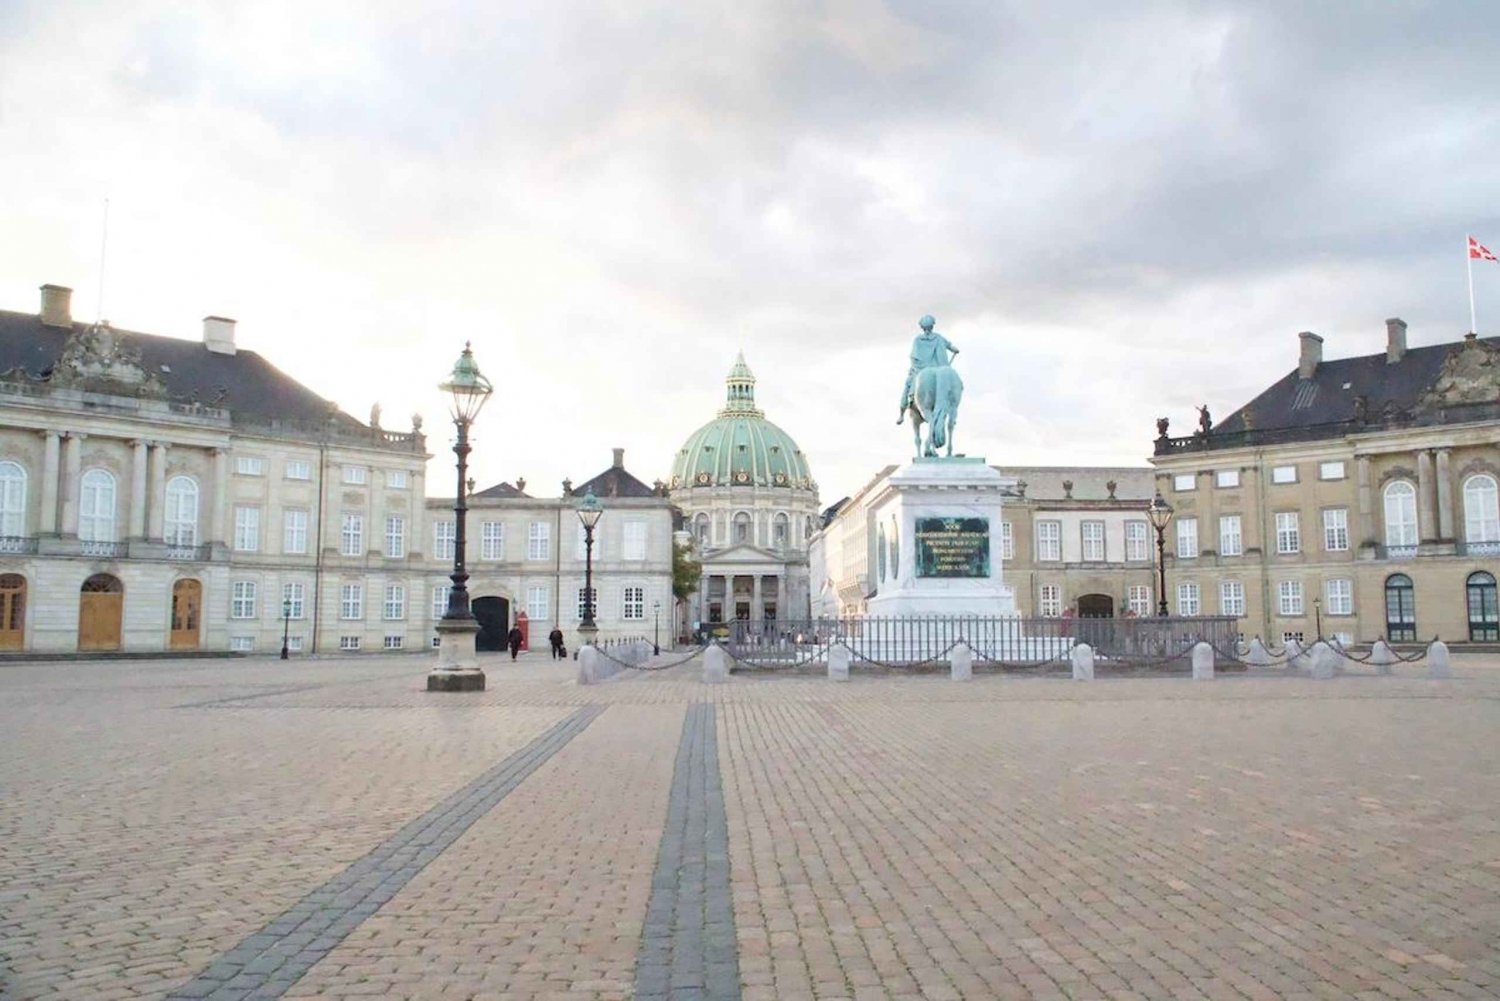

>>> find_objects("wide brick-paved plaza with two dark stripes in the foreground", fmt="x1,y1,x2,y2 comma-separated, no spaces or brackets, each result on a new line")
0,656,1500,1001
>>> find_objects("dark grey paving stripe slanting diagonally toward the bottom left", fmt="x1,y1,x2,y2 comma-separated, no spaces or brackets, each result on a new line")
167,705,605,1001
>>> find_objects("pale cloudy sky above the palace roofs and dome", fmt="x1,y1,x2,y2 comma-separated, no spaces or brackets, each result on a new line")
0,0,1500,503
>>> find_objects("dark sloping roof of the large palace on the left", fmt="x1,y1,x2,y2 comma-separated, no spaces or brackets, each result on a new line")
0,309,354,426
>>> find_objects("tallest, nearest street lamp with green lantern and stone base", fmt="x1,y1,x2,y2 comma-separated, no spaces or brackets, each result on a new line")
428,342,495,692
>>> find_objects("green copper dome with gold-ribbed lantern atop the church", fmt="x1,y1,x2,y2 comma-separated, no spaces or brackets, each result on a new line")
671,353,816,489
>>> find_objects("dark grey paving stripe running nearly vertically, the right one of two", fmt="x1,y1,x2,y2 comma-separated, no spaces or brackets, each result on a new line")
636,704,740,1001
